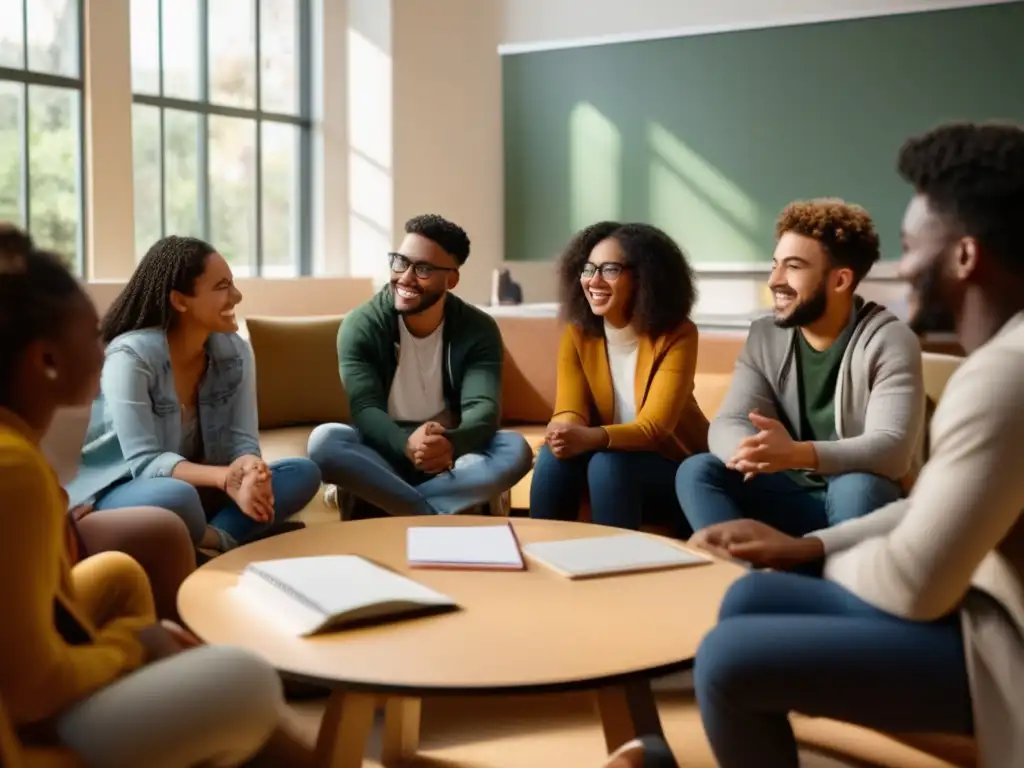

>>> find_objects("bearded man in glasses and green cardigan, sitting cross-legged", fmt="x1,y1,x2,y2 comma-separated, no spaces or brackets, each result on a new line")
308,215,532,515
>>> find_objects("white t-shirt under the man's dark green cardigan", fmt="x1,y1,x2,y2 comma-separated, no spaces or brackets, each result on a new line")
387,321,444,423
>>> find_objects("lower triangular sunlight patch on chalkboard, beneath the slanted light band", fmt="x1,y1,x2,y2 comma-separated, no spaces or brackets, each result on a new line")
647,158,762,264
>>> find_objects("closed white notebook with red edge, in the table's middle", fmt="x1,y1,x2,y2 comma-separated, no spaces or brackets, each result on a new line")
406,522,526,570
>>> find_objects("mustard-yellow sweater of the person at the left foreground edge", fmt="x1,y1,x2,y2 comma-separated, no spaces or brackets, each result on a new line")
0,410,153,727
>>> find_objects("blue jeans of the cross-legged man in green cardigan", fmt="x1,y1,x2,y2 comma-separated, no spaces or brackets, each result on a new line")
307,424,534,516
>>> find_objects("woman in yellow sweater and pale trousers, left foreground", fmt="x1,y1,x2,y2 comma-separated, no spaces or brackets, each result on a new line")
0,226,308,768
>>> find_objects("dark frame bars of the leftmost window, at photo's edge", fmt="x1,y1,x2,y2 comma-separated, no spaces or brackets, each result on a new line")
0,0,87,276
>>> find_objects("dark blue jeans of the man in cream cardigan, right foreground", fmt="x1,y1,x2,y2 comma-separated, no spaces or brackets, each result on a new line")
693,571,974,768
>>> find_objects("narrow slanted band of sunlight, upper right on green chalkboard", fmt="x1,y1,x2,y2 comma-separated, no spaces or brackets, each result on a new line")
647,123,761,232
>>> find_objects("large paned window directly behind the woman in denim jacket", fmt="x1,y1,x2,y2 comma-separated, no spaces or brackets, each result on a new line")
130,0,312,278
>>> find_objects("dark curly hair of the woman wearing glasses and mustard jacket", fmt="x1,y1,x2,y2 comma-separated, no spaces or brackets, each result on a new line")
558,221,697,337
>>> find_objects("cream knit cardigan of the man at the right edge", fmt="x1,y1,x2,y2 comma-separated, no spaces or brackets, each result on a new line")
811,312,1024,768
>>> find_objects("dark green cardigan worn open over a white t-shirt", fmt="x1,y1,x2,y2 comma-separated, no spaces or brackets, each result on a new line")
338,286,504,470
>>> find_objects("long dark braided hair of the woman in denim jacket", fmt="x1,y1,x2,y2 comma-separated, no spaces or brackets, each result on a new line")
100,234,216,344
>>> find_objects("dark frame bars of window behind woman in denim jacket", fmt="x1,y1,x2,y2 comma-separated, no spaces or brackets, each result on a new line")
134,0,313,278
